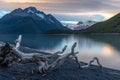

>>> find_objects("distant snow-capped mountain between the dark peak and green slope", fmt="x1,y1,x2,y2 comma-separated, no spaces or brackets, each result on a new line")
74,20,97,30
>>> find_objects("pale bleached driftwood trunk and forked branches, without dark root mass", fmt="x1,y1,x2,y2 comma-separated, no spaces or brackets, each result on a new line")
12,35,80,73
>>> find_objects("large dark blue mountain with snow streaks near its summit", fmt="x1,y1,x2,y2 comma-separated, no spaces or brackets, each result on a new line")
0,7,68,34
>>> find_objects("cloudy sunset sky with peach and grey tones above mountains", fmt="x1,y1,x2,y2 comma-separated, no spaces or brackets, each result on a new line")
0,0,120,22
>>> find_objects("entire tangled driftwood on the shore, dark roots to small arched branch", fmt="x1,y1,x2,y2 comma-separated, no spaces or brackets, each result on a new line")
0,35,101,74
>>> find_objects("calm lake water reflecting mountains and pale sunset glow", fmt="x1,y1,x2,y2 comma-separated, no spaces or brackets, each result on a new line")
0,34,120,70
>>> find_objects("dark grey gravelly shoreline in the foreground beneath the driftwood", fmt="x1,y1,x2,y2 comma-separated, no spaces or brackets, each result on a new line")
0,60,120,80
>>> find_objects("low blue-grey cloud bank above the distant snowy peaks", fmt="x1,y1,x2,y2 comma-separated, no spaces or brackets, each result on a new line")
54,14,105,21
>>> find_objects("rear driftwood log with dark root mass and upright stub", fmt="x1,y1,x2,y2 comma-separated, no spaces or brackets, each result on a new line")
0,35,66,66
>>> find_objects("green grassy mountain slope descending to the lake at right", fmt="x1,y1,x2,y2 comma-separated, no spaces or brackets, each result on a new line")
82,13,120,33
